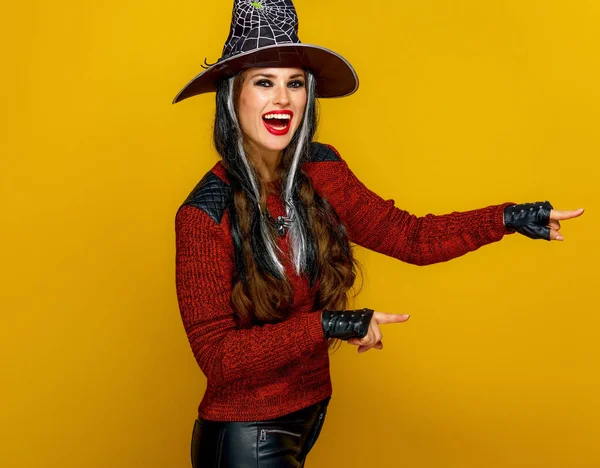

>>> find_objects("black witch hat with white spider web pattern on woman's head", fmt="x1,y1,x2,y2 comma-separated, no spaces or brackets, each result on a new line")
173,0,358,104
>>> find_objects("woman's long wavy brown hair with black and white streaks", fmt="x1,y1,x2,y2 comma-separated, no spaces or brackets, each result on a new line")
213,71,362,345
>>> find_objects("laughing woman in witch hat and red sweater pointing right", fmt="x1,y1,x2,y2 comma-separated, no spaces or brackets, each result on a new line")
175,1,580,467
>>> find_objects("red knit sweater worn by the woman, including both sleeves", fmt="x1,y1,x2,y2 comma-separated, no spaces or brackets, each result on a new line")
175,145,515,421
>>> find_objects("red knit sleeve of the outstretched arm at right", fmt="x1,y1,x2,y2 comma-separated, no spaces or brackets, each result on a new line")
318,145,515,266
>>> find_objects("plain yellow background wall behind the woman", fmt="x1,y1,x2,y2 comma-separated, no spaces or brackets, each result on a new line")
0,0,600,468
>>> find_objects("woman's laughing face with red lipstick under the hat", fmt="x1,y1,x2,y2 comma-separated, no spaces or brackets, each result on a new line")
238,68,306,151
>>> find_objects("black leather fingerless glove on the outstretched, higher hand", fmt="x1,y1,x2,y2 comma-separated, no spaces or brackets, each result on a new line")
504,201,553,240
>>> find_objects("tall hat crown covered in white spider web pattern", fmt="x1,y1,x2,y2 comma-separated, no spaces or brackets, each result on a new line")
220,0,300,60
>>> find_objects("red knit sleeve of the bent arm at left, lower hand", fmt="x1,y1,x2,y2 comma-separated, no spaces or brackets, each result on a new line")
175,206,325,386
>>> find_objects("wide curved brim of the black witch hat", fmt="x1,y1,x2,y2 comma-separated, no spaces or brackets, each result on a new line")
173,44,358,104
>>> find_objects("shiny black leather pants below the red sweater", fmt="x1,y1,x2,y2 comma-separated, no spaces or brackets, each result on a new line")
191,397,331,468
